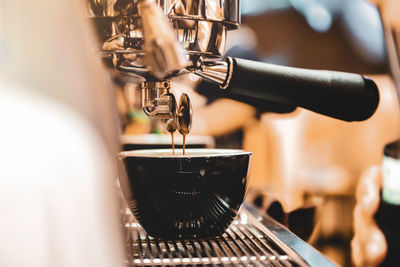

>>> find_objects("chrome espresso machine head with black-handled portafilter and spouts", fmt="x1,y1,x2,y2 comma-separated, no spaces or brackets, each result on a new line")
86,0,379,138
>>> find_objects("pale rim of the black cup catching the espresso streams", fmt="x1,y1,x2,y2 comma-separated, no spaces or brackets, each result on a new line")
118,148,252,159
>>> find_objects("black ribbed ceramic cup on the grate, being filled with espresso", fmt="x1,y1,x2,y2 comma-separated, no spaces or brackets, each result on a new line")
119,149,251,240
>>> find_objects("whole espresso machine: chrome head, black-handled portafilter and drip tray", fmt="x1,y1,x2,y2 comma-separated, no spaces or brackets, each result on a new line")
85,0,379,266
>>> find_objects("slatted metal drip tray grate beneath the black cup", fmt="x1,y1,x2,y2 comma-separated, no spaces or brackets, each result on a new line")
124,209,308,266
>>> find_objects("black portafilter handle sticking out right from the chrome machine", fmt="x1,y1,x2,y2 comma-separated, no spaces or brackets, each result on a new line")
224,57,379,121
